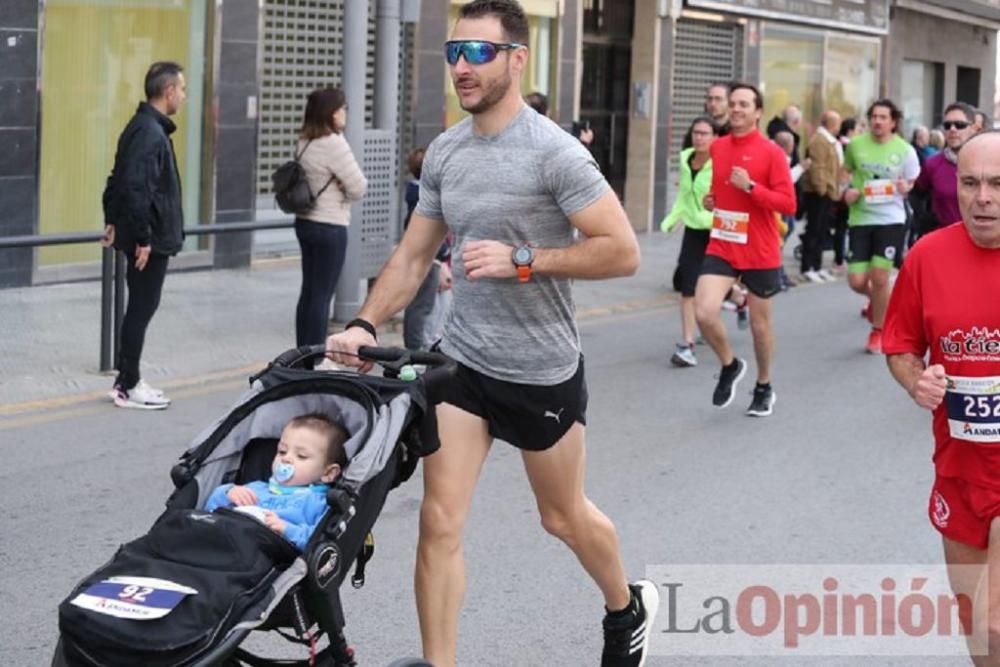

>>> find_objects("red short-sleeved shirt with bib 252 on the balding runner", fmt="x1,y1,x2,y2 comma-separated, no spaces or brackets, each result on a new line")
882,223,1000,489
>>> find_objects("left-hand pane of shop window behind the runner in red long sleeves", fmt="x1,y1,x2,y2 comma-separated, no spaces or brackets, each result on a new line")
760,25,823,138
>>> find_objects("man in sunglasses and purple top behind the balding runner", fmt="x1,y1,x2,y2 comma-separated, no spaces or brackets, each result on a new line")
914,102,976,236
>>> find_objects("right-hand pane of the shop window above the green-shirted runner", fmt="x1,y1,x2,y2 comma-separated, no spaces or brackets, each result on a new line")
824,35,880,118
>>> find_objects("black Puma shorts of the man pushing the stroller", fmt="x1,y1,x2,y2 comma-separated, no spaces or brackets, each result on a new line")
443,355,587,452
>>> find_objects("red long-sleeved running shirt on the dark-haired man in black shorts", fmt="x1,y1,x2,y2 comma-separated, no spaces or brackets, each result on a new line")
705,129,795,270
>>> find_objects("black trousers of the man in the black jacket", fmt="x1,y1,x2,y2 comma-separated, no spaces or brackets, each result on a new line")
115,253,170,391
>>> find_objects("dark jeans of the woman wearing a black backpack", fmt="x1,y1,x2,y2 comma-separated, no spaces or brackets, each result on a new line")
295,218,347,347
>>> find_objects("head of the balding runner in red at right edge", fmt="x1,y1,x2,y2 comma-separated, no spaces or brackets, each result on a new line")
958,130,1000,248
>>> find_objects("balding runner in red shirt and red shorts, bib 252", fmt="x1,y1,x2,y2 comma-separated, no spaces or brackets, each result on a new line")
882,132,1000,664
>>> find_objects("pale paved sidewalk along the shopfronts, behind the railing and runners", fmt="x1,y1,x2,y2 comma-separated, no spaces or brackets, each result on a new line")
0,233,681,408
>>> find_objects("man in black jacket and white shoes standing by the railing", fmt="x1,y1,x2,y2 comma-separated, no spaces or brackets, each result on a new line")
104,62,186,410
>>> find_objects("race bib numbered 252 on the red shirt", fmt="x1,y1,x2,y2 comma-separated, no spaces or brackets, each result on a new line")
944,376,1000,444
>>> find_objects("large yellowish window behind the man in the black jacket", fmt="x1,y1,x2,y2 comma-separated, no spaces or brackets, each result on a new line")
38,0,209,266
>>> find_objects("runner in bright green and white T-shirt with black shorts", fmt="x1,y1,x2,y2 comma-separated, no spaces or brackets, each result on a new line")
844,99,920,354
